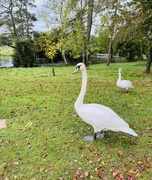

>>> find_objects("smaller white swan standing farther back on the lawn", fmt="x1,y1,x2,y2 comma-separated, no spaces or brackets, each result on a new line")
116,68,134,93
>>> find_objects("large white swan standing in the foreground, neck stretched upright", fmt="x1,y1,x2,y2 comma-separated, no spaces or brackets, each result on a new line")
73,63,138,141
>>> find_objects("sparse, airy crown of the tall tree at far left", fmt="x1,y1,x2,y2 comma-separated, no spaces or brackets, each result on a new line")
0,0,36,38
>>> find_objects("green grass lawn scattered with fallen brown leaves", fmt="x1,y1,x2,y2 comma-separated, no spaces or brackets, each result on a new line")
0,62,152,180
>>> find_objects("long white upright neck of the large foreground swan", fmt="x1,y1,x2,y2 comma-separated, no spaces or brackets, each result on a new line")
74,69,87,110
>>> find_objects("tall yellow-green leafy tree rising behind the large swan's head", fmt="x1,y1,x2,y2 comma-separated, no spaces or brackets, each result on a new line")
42,0,94,65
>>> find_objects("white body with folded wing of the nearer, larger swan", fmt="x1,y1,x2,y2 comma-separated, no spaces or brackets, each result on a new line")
77,104,129,131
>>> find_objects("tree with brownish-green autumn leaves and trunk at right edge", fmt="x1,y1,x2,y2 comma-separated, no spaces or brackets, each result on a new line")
117,0,152,73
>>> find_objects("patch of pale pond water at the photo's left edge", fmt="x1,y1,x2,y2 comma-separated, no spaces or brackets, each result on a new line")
0,56,13,67
